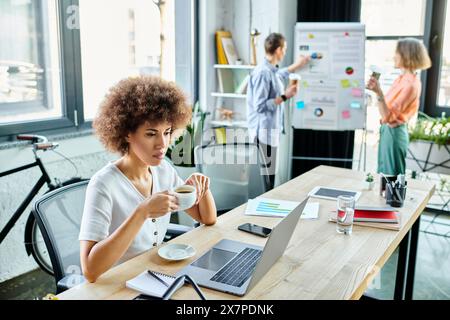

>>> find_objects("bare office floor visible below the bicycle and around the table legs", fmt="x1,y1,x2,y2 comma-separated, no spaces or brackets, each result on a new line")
0,213,450,300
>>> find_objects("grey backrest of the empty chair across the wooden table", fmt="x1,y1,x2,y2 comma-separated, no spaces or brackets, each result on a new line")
195,143,268,211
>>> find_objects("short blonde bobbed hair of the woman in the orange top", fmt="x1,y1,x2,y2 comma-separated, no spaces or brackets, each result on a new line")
396,38,431,70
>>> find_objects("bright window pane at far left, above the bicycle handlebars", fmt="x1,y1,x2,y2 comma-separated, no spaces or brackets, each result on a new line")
0,0,62,125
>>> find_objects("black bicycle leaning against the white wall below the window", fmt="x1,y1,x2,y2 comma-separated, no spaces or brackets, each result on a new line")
0,135,87,275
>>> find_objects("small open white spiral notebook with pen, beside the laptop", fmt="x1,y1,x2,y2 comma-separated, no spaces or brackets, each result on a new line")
126,270,183,298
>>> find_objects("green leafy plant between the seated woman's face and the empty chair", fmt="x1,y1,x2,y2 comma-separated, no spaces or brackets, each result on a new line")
167,102,208,179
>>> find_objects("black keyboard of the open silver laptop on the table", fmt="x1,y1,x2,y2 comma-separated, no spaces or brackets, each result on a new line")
211,248,262,287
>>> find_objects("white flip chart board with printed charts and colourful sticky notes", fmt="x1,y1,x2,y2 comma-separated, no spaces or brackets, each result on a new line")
292,23,366,130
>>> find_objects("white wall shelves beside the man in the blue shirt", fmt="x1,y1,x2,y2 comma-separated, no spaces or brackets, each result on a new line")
211,64,255,128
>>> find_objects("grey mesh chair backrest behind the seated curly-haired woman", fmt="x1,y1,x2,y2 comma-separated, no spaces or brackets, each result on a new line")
33,181,89,282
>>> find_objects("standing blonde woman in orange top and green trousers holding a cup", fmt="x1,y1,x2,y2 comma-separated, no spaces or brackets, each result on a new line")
367,38,431,175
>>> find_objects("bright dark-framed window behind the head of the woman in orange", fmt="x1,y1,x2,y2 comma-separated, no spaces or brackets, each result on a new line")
361,0,450,116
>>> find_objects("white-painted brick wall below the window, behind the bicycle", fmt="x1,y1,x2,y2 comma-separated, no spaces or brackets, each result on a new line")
0,135,116,282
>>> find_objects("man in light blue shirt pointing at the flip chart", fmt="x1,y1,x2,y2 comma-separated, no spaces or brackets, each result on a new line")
247,33,311,190
